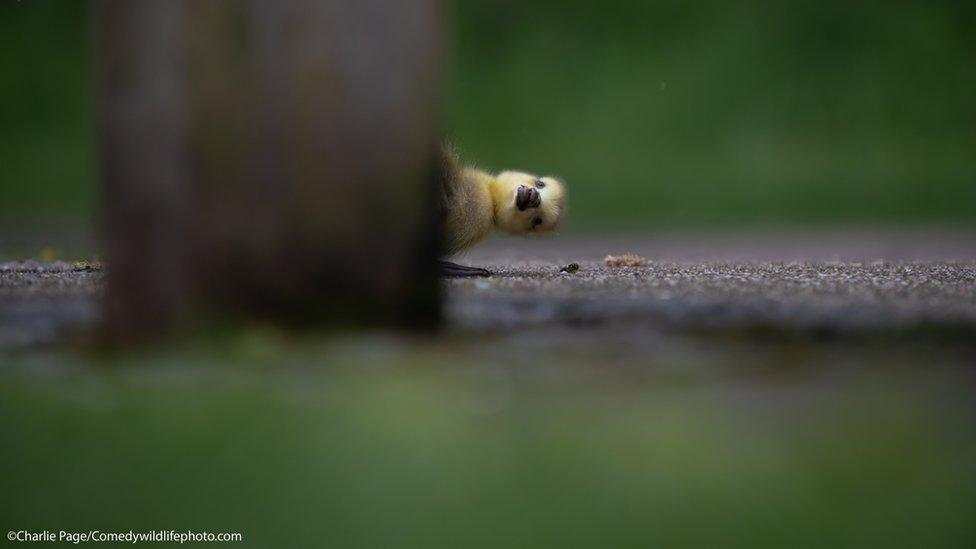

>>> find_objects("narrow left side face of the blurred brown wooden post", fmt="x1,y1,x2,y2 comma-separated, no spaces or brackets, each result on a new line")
97,0,190,340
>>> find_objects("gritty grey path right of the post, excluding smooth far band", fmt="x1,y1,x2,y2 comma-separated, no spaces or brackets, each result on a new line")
448,261,976,334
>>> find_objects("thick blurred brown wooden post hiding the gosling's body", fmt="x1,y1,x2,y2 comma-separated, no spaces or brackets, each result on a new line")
98,0,440,340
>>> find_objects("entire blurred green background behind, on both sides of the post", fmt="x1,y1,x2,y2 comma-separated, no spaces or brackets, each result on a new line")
0,0,976,229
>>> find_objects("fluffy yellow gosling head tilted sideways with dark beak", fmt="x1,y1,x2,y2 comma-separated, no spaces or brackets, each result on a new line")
492,172,566,235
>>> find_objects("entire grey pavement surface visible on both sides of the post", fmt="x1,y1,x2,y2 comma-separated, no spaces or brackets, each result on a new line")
0,233,976,354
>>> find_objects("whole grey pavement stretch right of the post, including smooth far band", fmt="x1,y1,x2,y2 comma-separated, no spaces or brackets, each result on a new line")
447,234,976,334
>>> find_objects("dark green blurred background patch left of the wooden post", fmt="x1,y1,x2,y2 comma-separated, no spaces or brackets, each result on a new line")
0,0,96,220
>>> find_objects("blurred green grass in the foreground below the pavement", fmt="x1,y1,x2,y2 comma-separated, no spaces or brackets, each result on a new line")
0,336,976,547
